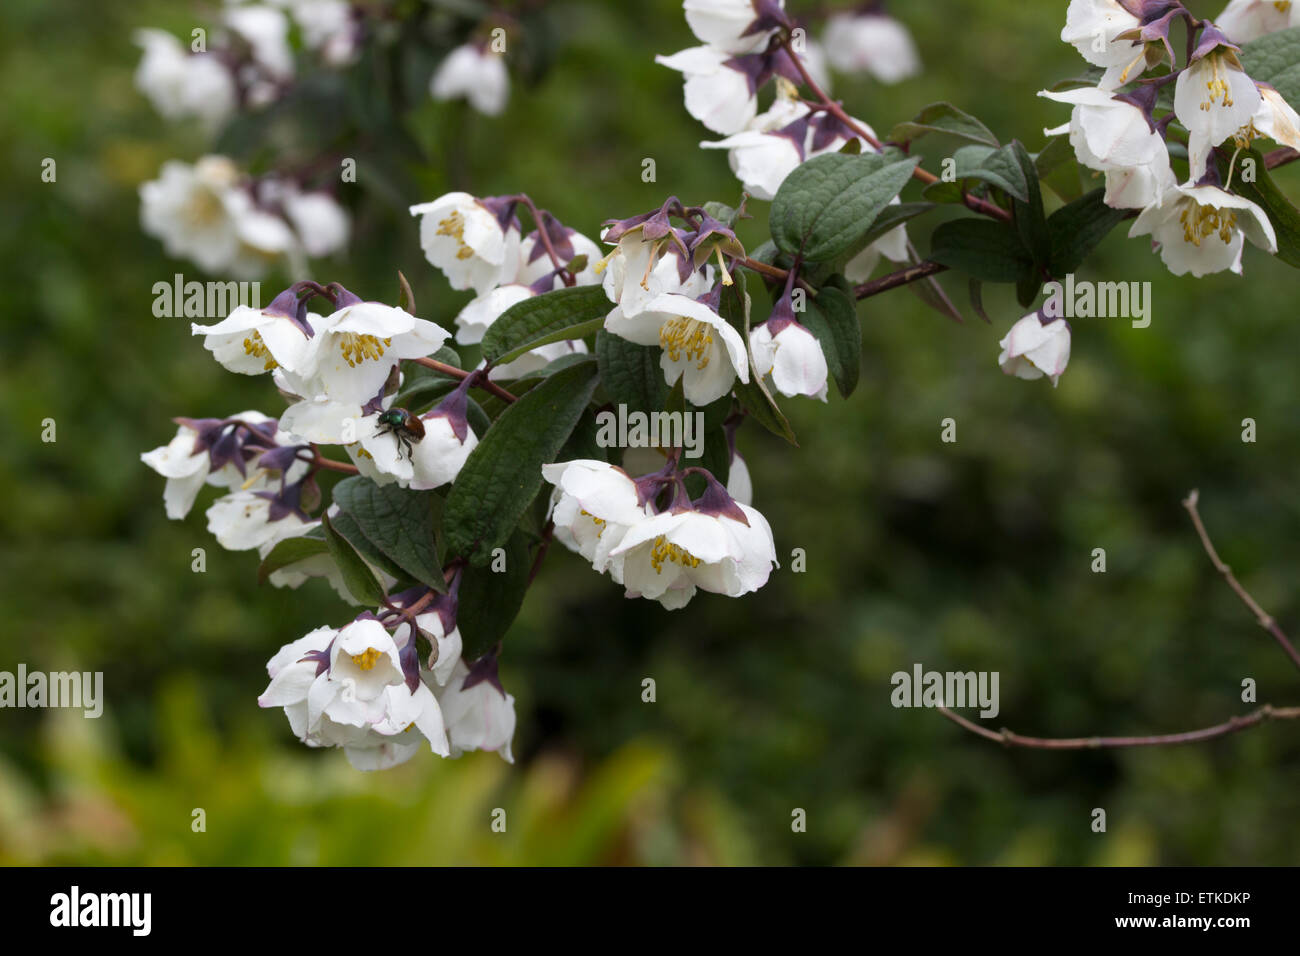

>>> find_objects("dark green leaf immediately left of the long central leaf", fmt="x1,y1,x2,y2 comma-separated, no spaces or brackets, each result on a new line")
334,476,446,591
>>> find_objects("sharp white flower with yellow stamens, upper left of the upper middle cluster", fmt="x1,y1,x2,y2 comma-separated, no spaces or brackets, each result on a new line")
411,193,520,295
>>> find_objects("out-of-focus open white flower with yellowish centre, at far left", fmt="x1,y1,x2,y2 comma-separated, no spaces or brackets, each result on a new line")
140,156,296,278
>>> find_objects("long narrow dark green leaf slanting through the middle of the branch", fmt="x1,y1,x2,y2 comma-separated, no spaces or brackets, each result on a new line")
443,358,597,564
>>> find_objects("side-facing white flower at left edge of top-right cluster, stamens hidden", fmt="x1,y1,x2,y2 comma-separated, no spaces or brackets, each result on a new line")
1039,87,1174,209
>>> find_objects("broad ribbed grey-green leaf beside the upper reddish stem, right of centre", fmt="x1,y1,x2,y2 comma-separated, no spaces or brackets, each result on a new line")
770,152,920,263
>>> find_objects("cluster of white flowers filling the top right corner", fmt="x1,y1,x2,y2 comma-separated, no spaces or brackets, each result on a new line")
1040,0,1300,277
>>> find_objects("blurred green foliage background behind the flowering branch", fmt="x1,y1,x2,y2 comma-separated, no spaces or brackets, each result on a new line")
0,0,1300,865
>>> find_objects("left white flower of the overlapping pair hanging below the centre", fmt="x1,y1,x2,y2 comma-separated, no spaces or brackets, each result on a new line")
542,459,650,584
